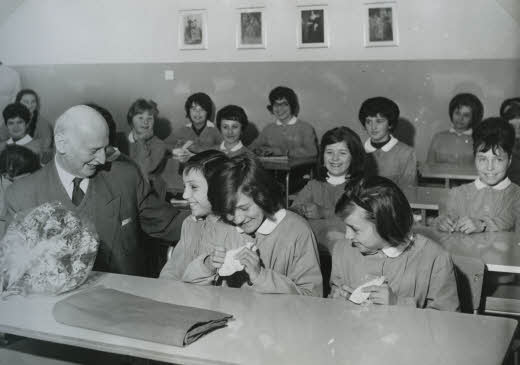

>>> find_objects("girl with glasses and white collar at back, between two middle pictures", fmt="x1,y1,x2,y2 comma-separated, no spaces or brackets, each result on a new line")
250,86,318,157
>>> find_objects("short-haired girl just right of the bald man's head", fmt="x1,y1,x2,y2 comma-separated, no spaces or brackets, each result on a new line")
118,99,170,200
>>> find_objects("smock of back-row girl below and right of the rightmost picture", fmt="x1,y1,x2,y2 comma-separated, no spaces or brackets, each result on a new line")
426,128,475,165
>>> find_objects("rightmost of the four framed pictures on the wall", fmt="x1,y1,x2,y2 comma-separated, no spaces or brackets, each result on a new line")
363,2,399,47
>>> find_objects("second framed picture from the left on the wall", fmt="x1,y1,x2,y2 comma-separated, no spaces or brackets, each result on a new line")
236,7,267,48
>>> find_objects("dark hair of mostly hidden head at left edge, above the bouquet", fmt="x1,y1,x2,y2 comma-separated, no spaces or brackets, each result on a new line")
0,144,41,178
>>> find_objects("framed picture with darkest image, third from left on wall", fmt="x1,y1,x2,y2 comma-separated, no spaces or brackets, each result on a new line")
296,5,329,48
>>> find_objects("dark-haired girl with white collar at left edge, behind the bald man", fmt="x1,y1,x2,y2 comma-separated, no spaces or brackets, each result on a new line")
0,103,41,156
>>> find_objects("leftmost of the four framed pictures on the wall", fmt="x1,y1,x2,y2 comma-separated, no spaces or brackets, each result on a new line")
179,9,208,49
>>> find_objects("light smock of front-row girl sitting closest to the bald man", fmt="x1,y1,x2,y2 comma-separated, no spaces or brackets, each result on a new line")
159,215,236,280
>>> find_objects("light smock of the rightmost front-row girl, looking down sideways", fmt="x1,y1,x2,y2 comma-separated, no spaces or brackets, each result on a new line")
330,234,459,311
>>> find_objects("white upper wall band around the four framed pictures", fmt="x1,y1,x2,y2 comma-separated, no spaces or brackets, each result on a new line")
0,0,520,65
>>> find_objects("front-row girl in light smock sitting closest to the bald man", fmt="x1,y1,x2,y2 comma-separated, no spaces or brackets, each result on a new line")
159,150,231,280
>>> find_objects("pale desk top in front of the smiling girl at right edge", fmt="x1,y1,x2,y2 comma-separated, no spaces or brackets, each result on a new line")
414,226,520,274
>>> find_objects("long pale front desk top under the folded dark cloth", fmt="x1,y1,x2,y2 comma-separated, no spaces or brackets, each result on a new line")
0,273,517,365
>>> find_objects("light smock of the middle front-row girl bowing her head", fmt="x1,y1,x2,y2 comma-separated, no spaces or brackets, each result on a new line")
182,209,323,297
